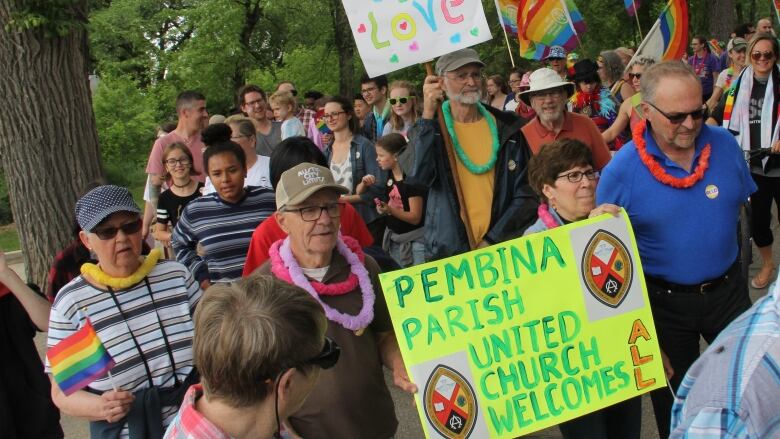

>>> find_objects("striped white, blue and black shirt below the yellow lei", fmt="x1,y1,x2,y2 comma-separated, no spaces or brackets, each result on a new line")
45,260,202,437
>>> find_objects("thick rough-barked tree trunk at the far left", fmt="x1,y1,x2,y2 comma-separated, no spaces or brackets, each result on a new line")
0,0,103,292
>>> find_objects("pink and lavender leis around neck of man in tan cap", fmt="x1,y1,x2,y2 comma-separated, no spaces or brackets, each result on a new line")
268,236,376,335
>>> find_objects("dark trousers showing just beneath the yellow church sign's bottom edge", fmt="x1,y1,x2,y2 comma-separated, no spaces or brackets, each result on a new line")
558,396,642,439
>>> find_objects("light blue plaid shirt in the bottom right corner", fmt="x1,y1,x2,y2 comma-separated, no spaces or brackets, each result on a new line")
670,282,780,439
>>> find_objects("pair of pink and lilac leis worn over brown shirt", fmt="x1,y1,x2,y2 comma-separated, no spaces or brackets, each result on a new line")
269,237,376,336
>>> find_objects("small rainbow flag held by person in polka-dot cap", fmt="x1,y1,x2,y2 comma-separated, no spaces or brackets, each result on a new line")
46,319,116,395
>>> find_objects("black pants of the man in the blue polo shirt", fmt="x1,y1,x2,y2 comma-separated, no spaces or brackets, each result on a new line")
647,263,751,439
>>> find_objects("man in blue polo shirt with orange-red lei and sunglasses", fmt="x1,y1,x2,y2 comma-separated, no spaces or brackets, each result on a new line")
596,62,756,438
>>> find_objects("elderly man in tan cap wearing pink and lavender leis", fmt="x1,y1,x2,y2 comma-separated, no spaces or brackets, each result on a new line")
258,163,417,438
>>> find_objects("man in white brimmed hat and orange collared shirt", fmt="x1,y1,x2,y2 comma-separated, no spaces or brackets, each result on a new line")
520,68,612,171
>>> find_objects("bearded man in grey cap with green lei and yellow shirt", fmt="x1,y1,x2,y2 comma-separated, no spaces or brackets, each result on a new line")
407,49,538,259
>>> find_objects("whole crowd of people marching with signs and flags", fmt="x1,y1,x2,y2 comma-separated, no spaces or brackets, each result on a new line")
0,15,780,439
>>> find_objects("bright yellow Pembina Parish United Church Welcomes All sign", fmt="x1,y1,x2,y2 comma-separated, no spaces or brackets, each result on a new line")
381,213,666,439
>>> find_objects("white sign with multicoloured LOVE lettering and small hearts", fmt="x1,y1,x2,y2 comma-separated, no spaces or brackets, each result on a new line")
343,0,492,77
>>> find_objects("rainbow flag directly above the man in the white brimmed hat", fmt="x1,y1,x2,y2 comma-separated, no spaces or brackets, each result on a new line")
517,0,585,60
